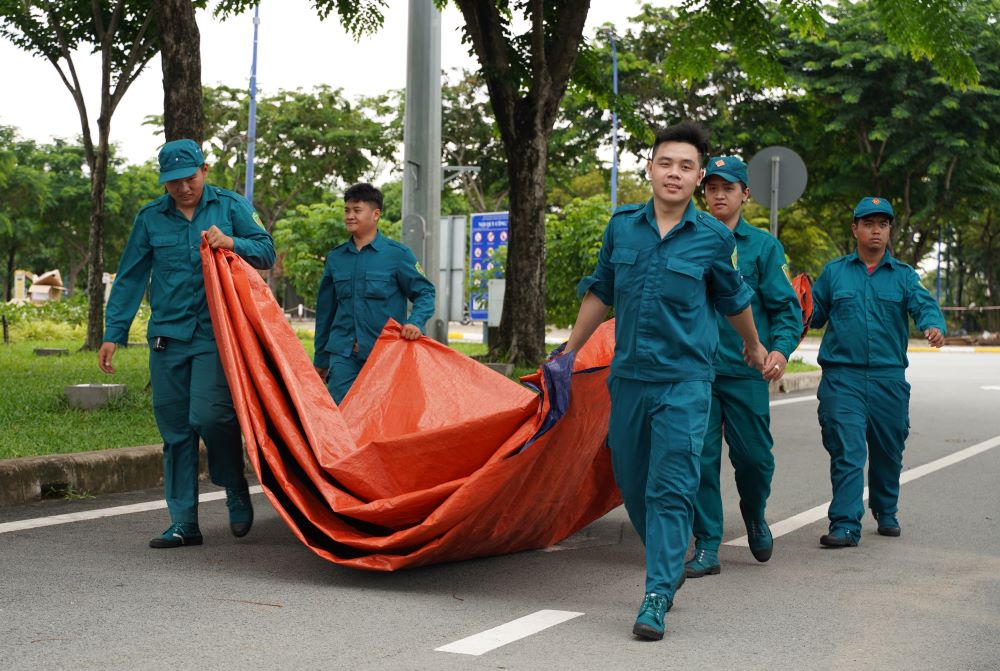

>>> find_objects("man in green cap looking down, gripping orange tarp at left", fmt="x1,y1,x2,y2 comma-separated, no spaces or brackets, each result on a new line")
98,140,274,548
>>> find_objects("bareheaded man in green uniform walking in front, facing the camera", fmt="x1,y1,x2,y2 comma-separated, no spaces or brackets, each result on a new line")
566,123,767,640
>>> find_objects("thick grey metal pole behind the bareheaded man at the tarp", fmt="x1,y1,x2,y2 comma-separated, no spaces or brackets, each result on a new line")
403,0,448,343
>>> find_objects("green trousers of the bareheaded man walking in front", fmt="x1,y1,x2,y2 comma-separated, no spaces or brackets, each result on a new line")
608,375,711,599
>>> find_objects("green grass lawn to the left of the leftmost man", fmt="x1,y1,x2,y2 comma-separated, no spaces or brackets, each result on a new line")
0,339,161,459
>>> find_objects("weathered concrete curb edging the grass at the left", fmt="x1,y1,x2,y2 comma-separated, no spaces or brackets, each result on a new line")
0,445,207,508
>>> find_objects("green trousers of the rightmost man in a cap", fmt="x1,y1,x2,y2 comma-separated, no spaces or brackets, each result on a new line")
816,368,910,531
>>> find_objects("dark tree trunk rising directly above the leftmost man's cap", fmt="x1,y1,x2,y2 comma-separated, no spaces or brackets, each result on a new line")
153,0,205,144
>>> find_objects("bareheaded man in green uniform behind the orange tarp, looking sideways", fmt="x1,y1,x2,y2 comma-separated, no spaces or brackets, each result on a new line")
313,184,434,405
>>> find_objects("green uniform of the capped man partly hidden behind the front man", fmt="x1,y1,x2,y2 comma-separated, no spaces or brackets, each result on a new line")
693,217,802,551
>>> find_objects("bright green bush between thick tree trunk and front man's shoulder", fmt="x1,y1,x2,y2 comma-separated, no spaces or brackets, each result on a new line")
545,196,611,327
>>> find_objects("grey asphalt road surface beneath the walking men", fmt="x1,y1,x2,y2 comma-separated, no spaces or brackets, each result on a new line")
0,353,1000,671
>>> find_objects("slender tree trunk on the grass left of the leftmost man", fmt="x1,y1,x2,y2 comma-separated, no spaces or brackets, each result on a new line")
82,122,111,350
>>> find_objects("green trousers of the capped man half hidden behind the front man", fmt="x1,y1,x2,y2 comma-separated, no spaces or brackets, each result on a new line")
692,375,774,550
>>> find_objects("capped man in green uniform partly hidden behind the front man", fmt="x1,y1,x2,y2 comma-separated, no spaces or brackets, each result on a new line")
685,156,802,578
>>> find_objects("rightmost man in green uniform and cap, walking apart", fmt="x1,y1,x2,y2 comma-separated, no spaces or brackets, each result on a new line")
811,197,945,548
